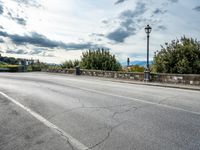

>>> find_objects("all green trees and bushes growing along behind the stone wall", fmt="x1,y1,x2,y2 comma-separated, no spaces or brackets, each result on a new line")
0,36,200,74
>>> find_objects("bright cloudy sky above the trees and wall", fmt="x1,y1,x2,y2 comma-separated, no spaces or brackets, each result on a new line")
0,0,200,64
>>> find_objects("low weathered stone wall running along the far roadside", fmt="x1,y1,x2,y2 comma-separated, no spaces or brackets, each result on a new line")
43,69,200,85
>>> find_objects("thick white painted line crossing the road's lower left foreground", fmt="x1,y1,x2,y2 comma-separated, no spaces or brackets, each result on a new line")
0,91,89,150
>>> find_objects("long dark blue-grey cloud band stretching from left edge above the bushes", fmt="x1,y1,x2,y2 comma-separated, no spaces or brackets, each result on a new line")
0,31,102,50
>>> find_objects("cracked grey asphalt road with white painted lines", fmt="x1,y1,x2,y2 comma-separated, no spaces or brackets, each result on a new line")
0,73,200,150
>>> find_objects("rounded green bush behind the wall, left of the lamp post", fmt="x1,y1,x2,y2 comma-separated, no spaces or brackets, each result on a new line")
80,49,122,71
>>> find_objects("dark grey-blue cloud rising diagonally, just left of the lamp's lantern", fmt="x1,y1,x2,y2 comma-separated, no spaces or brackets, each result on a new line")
106,2,146,43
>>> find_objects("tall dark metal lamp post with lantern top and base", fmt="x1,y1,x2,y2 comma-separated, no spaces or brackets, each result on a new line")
144,25,152,81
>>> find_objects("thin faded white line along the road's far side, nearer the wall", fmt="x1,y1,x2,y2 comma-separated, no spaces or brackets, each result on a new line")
73,85,200,115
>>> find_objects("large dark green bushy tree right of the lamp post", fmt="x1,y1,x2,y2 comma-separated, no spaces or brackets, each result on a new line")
153,36,200,74
